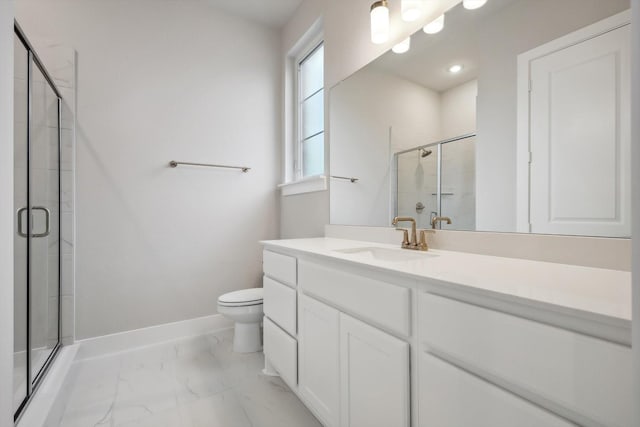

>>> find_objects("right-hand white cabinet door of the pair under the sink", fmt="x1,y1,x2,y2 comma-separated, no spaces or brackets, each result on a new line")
340,314,409,427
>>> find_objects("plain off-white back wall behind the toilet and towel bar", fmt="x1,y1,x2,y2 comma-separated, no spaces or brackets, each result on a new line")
18,0,281,339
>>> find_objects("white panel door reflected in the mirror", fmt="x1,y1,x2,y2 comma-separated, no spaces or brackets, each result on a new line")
530,25,631,237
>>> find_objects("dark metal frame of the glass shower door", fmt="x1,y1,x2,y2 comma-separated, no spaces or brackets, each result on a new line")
13,21,62,423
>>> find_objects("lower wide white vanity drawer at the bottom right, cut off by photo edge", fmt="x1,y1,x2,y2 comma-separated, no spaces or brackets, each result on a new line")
418,353,576,427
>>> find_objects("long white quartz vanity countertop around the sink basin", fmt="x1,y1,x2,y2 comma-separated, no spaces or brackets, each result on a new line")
261,238,631,322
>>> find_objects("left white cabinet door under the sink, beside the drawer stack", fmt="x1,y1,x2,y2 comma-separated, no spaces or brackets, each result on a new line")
298,295,340,427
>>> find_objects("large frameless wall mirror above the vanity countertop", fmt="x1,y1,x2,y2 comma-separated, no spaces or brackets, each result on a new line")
329,0,631,237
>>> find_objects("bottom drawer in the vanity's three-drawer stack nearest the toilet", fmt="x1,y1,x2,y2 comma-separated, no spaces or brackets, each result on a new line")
263,317,298,387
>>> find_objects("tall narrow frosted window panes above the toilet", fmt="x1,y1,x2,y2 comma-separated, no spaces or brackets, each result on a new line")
295,43,324,179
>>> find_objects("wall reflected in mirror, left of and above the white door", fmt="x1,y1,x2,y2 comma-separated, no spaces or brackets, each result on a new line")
476,0,629,231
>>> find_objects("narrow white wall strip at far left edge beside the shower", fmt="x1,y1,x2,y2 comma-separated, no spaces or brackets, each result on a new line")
0,0,14,427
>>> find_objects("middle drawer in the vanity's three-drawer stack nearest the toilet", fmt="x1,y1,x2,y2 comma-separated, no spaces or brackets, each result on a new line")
262,276,297,336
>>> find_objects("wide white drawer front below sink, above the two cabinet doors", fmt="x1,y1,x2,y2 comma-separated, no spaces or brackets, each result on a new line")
299,260,411,337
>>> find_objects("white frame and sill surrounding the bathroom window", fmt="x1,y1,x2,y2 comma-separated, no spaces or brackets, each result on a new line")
278,28,327,196
